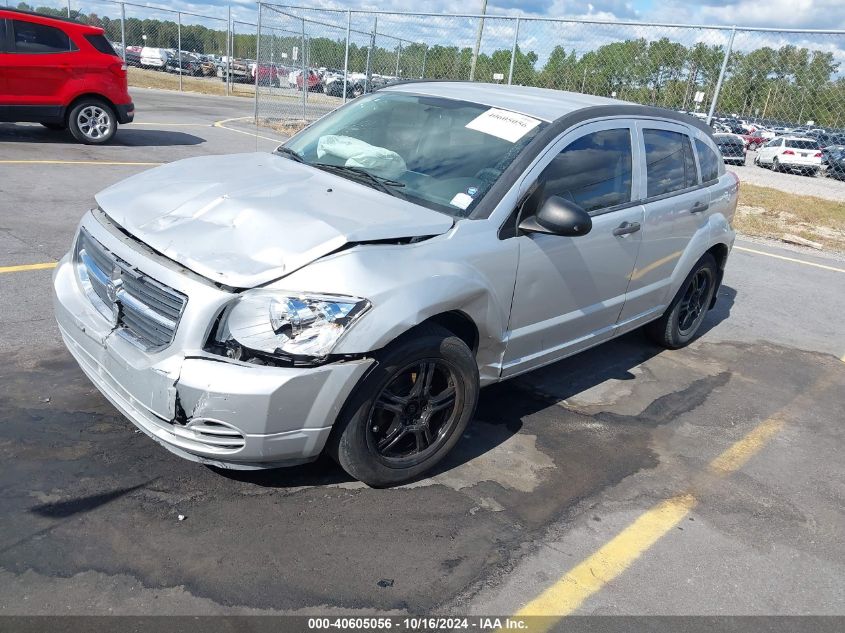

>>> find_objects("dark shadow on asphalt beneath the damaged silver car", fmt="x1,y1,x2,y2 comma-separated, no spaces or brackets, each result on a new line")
218,286,737,489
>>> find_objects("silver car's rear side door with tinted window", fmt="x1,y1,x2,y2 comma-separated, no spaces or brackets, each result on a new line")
619,120,710,329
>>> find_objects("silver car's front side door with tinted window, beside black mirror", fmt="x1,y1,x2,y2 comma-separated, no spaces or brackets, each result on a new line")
502,120,643,377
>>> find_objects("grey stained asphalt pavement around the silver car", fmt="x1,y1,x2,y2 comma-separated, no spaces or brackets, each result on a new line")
0,90,845,615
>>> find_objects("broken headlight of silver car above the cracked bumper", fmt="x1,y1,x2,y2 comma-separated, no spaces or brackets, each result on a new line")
215,290,370,359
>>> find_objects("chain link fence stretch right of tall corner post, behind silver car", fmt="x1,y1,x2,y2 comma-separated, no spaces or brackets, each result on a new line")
256,4,845,143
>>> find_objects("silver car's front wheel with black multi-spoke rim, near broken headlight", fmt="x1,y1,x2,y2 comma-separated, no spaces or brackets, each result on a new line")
328,325,479,487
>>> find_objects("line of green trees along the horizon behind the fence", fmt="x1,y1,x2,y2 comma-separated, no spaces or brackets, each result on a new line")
18,3,845,127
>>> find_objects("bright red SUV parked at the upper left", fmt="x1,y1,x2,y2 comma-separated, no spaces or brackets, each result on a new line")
0,9,135,144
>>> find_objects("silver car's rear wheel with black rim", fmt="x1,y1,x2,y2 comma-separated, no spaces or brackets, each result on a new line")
646,253,717,349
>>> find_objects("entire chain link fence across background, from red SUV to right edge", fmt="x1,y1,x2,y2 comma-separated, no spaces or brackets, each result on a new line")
6,0,845,142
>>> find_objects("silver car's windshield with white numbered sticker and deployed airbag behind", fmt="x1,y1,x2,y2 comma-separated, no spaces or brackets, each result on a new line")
284,92,547,217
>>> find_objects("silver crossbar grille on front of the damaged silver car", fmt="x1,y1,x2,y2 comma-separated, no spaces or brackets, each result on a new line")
76,229,188,351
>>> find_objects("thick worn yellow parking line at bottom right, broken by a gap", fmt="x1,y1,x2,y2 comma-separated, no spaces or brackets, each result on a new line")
515,416,783,633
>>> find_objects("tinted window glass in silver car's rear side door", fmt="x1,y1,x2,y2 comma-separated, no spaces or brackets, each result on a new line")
643,129,698,198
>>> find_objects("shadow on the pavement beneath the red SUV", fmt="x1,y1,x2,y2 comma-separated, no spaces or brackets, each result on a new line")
0,123,206,147
